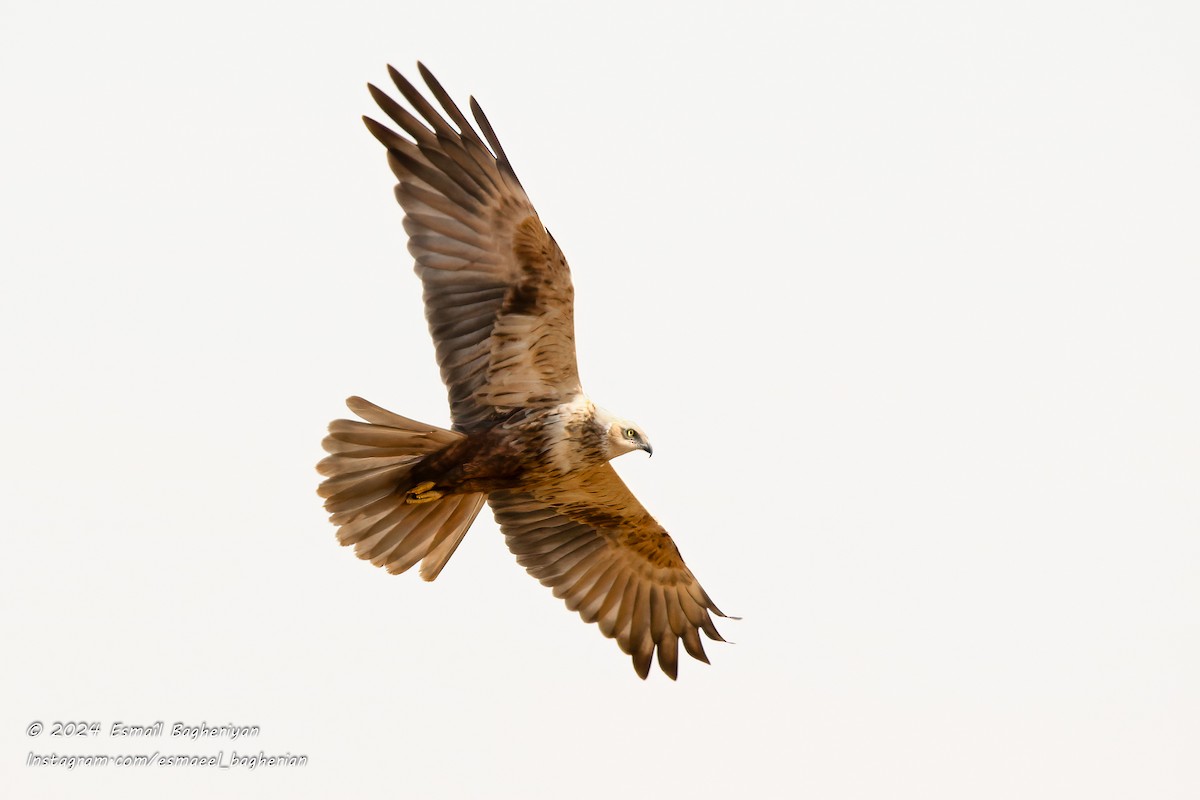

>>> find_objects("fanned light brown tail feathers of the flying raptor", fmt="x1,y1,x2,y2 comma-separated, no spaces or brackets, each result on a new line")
317,397,486,581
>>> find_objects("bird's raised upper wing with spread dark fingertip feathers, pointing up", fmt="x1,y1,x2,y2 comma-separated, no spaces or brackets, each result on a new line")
364,65,580,433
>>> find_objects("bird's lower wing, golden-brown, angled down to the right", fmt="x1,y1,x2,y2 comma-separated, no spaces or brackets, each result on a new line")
487,464,725,680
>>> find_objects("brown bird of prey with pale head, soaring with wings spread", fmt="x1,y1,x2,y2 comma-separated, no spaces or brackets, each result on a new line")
318,64,725,680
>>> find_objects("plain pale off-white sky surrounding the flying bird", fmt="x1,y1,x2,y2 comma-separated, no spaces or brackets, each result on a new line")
0,0,1200,800
